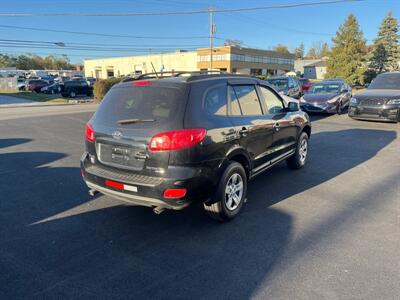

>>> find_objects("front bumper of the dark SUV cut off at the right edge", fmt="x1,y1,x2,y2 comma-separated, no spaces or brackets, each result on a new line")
349,105,400,122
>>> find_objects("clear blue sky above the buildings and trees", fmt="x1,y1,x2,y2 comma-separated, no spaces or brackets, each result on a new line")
0,0,400,63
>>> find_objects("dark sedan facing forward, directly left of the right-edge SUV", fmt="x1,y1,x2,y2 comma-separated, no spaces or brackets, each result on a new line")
300,79,352,114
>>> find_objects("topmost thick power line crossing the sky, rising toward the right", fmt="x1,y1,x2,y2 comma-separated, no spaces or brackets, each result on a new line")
0,0,364,17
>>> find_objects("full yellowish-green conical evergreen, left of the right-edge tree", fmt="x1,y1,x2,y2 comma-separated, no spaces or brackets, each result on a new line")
325,14,367,84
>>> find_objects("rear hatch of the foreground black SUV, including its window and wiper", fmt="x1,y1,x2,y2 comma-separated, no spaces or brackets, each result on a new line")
90,80,187,176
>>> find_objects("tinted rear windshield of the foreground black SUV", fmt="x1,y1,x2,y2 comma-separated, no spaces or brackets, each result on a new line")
96,86,184,126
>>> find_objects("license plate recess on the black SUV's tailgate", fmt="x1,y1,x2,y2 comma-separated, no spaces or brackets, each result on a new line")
96,143,145,170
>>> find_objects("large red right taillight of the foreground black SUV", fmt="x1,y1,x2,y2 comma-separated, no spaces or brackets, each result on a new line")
149,128,207,151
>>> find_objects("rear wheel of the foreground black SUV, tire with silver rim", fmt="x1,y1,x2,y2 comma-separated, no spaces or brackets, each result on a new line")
203,162,247,222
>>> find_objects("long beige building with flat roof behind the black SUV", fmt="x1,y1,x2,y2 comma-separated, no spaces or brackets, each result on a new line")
84,46,294,78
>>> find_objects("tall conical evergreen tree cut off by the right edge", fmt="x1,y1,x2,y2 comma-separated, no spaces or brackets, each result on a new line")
370,11,400,73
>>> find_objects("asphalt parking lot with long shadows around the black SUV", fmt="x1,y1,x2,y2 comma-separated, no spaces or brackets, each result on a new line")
0,106,400,299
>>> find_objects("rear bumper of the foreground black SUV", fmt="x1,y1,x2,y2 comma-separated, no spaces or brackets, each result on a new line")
81,152,218,210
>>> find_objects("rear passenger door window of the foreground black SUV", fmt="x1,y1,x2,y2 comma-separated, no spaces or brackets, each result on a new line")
233,85,262,116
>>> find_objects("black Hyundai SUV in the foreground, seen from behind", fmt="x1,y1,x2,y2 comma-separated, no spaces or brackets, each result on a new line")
81,72,311,221
